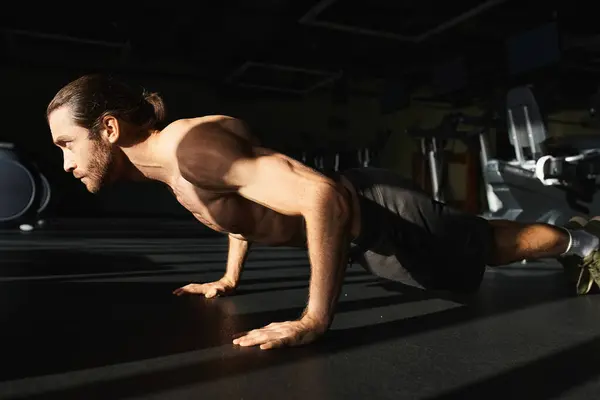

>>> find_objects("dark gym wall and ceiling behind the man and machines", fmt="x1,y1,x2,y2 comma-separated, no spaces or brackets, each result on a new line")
0,0,600,222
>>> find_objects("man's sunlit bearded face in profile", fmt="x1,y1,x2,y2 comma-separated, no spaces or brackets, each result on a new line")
48,107,115,193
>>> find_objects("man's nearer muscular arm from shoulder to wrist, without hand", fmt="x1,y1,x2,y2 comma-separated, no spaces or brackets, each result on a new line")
178,125,350,330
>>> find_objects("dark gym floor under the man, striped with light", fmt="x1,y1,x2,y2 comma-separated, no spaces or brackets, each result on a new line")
0,221,600,400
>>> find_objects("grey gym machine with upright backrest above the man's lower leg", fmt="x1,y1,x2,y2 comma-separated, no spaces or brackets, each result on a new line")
482,86,600,225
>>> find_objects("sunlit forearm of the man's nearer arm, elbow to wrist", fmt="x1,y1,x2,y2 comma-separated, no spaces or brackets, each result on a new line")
303,194,350,327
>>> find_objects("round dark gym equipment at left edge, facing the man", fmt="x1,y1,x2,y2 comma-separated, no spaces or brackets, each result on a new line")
0,142,51,230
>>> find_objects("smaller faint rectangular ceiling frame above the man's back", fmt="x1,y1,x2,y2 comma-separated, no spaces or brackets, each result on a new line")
226,61,342,95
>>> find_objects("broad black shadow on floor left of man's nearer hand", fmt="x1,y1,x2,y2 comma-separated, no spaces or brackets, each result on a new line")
0,282,233,381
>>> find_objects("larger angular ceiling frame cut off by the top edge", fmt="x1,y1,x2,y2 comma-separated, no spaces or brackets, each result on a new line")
299,0,507,43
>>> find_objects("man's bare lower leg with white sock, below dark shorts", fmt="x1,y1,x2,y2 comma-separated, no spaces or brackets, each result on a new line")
487,216,600,266
